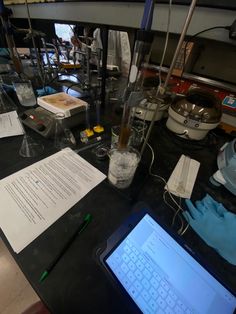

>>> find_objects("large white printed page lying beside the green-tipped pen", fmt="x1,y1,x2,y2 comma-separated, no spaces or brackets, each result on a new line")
0,148,106,253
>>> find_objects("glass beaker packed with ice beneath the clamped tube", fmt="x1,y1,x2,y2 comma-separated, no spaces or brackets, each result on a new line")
108,147,141,189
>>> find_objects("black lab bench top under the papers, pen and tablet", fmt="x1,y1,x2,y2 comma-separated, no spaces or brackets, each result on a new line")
0,121,236,314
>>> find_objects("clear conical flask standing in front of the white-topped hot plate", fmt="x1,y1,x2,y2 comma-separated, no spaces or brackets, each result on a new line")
54,113,76,149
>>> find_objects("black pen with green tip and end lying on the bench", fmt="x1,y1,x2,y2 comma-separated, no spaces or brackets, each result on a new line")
39,214,92,282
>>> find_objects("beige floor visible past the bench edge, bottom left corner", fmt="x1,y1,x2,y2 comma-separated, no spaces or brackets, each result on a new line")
0,238,39,314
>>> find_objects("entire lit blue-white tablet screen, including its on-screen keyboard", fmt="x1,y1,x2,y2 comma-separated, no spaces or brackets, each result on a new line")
105,214,236,314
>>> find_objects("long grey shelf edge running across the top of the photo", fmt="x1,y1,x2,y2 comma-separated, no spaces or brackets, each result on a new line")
9,1,235,43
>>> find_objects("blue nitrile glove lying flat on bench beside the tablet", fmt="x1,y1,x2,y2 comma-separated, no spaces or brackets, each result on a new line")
183,195,236,265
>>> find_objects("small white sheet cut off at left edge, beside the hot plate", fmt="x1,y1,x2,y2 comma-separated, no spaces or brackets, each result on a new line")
0,111,24,138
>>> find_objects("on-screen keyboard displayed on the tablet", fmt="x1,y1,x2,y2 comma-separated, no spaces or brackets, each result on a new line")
108,239,195,314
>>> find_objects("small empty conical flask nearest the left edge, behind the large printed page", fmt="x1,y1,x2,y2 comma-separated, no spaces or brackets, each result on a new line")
19,134,44,157
